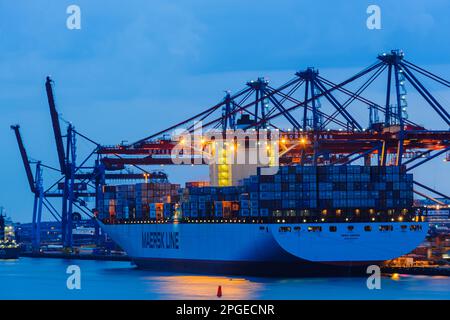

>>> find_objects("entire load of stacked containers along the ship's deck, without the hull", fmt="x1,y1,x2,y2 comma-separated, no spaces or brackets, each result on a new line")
99,165,413,220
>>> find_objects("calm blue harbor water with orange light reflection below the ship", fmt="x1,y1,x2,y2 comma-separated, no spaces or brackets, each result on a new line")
0,258,450,300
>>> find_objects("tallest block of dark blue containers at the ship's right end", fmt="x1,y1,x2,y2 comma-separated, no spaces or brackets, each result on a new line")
247,166,413,217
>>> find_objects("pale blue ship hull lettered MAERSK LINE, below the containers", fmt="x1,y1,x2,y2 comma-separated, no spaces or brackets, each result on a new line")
96,222,428,277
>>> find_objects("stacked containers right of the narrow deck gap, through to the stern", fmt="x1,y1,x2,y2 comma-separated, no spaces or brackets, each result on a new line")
182,166,413,218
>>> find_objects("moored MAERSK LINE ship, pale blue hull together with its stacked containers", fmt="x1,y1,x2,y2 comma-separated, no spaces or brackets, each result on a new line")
97,165,428,276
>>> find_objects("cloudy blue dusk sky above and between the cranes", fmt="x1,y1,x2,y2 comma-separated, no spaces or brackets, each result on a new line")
0,0,450,222
